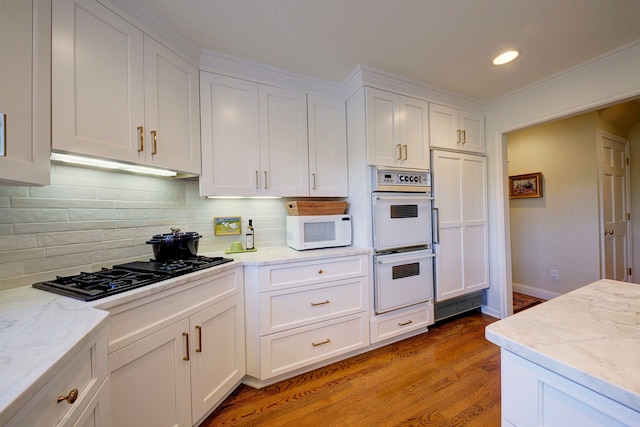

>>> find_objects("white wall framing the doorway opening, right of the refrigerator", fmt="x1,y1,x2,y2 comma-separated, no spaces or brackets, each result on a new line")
485,42,640,317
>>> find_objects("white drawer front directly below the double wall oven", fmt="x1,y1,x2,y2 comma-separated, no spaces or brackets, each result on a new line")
371,303,434,344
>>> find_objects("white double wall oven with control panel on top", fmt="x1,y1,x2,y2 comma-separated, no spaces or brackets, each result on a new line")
371,168,434,314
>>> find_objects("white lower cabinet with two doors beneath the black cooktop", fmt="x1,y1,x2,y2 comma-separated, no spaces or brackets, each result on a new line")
109,267,245,427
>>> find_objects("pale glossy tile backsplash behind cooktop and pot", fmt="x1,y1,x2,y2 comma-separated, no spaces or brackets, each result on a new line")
0,165,287,290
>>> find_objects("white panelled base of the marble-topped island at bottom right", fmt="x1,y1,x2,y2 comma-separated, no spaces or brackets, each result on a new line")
500,350,640,427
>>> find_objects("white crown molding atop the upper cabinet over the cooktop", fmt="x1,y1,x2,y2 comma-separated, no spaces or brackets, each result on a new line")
98,0,202,67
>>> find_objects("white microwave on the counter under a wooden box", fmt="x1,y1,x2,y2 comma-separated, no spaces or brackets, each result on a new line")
287,215,351,251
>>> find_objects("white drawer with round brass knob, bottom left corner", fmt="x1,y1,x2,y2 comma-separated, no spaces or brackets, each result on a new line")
6,330,107,427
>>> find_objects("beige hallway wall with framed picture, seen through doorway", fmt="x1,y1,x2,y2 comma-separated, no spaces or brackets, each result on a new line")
508,112,600,299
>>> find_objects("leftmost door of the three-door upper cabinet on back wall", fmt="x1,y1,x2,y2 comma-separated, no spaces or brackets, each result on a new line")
200,72,260,196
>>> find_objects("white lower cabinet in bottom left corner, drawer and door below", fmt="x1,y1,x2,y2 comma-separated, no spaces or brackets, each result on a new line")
5,329,111,427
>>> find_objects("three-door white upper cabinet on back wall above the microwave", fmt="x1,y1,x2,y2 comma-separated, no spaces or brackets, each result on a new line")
200,71,348,197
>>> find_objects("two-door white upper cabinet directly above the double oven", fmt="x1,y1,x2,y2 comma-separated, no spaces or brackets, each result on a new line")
365,87,430,170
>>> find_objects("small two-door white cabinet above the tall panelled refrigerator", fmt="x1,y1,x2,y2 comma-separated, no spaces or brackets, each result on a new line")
429,103,484,153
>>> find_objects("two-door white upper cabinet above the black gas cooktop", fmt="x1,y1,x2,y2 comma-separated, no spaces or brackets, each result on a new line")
52,0,200,174
